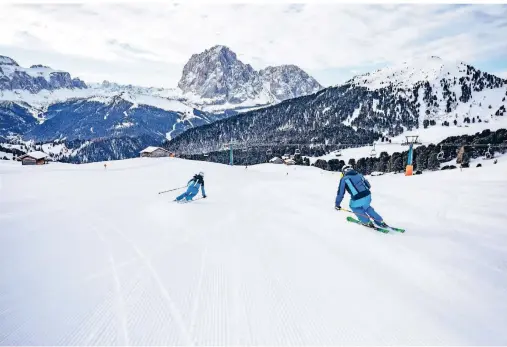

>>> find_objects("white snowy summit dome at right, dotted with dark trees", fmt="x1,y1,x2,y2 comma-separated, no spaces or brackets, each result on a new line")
346,56,507,130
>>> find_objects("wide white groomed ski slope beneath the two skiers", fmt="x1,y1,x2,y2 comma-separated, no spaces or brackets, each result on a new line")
0,157,507,345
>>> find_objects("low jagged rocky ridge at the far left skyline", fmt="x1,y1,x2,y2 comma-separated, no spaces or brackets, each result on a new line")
0,56,87,93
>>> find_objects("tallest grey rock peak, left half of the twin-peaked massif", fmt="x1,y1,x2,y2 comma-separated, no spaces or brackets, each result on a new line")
178,46,262,103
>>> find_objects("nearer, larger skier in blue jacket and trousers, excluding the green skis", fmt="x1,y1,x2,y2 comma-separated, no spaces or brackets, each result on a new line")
335,165,387,227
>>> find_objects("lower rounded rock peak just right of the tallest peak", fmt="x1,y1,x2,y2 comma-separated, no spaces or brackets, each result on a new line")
259,65,322,100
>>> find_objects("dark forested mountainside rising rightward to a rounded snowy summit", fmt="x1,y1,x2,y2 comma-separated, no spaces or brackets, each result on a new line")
169,57,507,158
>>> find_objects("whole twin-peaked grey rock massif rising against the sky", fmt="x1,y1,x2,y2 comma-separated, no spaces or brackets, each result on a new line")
178,46,322,104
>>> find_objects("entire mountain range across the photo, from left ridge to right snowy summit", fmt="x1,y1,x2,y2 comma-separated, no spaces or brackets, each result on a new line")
0,46,507,167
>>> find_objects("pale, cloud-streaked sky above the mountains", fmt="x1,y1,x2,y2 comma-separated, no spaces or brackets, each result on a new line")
0,2,507,87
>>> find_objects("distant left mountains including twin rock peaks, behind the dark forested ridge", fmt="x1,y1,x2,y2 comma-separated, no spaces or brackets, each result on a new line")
0,46,322,160
